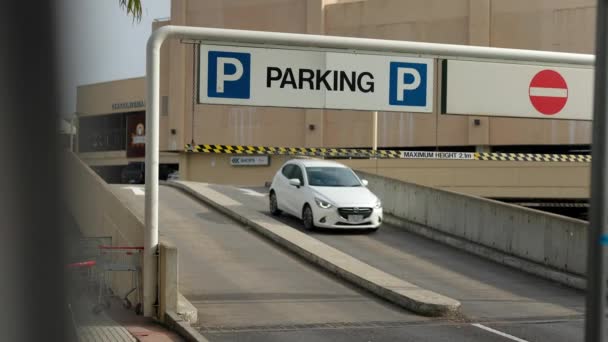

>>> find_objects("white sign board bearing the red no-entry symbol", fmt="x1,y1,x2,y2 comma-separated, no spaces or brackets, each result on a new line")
442,60,593,120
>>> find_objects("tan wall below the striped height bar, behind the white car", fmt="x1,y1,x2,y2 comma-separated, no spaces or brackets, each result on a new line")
180,153,590,199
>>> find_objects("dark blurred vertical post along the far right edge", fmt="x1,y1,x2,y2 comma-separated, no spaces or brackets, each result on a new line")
585,0,608,342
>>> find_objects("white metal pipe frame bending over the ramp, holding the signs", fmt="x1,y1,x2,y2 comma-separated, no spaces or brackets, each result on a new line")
143,25,595,316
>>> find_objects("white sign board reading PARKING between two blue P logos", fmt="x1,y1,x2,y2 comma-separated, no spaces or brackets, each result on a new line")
198,45,434,113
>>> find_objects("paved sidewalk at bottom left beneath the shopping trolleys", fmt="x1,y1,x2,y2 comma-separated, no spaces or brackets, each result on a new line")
72,298,185,342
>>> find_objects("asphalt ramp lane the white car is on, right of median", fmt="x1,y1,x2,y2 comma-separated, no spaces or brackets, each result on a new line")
197,186,604,342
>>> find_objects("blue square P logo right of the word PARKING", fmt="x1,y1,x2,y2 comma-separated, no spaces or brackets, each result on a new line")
388,62,427,107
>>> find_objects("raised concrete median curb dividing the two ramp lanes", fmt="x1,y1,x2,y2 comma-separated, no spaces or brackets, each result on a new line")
167,181,460,316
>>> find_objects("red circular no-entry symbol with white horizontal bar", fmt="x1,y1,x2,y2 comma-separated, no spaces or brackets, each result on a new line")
528,69,568,115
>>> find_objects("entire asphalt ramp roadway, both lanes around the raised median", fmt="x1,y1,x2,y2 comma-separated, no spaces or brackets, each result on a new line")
112,185,604,342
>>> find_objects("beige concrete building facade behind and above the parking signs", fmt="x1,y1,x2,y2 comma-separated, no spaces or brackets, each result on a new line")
78,0,596,174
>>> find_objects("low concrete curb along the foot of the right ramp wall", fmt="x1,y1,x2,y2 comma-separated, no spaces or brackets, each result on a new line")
384,213,587,291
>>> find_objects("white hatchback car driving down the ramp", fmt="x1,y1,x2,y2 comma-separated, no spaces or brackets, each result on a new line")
269,159,382,230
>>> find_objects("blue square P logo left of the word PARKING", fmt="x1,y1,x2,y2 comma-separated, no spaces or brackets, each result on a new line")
207,51,251,99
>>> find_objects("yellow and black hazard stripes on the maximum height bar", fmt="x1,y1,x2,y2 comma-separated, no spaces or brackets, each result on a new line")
185,144,591,163
